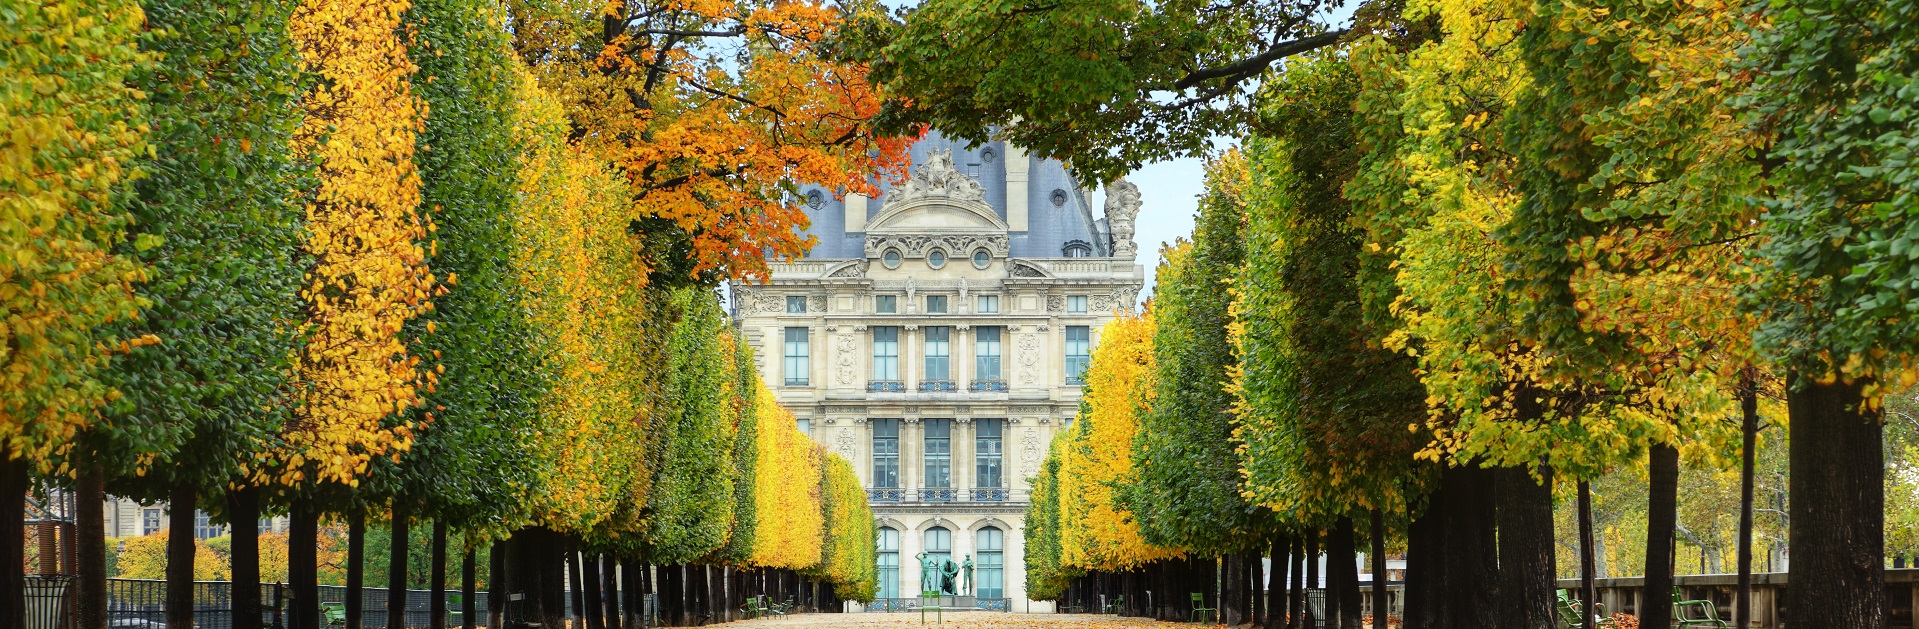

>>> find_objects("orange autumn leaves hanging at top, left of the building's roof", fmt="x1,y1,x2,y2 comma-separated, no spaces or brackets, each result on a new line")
512,0,908,276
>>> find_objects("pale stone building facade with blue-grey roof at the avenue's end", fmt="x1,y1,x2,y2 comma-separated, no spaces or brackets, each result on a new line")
731,134,1144,612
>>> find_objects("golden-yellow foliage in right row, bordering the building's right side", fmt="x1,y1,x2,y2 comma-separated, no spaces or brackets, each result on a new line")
1059,313,1186,570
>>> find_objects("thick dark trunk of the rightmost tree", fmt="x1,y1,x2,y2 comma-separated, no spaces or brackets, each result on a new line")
1787,382,1886,629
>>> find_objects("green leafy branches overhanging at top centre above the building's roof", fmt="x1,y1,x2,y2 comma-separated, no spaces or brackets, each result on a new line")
871,0,1345,182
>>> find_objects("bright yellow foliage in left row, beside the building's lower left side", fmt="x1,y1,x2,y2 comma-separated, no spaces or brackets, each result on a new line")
748,384,825,570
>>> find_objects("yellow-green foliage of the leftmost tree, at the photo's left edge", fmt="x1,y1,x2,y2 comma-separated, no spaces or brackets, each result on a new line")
0,0,150,466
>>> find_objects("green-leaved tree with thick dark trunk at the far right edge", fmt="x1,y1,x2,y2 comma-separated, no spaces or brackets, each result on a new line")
1741,0,1919,629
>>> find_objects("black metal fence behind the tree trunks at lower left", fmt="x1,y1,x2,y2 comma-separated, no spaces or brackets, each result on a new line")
94,579,487,629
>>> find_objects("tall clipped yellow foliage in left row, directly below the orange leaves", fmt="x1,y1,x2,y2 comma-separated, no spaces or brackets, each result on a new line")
514,71,670,533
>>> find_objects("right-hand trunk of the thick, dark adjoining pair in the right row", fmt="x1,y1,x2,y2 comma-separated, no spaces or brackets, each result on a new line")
1493,468,1558,629
